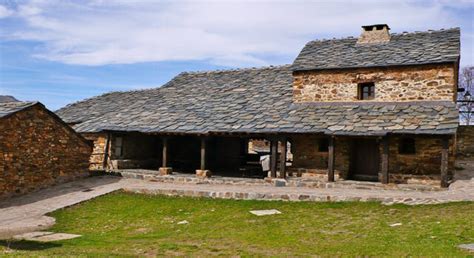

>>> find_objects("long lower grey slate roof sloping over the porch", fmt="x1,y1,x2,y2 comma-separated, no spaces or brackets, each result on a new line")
57,65,458,135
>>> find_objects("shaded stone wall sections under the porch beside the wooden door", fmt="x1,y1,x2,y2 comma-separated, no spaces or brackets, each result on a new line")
289,135,454,184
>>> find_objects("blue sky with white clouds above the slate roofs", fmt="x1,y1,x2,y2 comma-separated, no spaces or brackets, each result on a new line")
0,0,474,110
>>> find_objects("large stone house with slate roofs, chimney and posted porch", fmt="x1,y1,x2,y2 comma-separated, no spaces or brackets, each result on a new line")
57,24,460,186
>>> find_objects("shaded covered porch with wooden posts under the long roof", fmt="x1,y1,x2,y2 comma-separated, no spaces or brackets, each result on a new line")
104,132,454,187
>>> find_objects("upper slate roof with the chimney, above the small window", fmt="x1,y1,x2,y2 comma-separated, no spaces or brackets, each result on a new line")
292,28,460,71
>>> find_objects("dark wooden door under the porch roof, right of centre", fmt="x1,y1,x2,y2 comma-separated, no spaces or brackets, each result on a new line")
350,139,380,181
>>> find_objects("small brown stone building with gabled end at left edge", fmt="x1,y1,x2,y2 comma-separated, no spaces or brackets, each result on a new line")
0,101,91,198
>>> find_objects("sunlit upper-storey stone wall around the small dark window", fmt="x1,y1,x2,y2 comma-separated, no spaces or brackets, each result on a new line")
293,65,456,102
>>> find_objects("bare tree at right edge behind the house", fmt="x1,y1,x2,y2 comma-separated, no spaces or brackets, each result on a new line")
457,66,474,125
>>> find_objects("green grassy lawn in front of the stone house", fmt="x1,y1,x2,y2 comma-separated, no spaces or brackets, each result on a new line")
0,192,474,256
